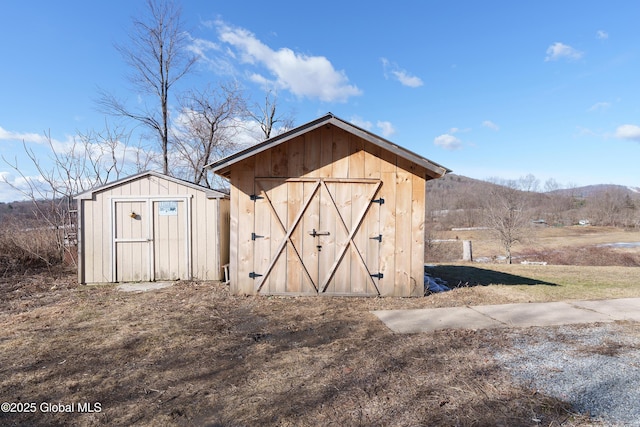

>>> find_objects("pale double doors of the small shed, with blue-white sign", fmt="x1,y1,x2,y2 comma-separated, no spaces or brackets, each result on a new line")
112,199,190,282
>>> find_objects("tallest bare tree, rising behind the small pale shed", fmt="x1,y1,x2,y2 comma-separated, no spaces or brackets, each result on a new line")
98,0,197,174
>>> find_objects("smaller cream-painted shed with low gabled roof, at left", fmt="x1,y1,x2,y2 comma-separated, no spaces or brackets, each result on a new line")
75,172,229,283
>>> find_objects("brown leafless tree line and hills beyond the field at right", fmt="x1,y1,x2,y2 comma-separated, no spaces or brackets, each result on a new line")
427,174,640,263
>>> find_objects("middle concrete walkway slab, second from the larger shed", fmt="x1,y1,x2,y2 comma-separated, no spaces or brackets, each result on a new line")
473,302,615,327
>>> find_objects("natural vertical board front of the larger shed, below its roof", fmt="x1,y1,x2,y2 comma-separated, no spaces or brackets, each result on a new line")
230,125,426,296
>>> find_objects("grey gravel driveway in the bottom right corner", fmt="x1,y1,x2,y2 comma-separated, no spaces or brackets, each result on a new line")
494,322,640,426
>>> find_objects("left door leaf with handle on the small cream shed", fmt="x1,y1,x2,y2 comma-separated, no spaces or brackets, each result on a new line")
112,200,151,282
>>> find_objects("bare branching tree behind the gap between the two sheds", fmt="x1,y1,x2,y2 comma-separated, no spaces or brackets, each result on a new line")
175,83,246,187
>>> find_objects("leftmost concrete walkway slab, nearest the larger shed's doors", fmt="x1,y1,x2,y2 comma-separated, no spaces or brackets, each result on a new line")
372,307,504,334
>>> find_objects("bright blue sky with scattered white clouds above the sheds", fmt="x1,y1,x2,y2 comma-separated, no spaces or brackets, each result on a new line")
0,0,640,201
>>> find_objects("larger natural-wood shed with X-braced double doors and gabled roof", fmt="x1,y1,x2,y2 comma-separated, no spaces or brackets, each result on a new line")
208,113,449,296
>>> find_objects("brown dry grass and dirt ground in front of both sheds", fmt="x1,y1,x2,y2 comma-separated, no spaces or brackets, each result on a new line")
0,273,612,426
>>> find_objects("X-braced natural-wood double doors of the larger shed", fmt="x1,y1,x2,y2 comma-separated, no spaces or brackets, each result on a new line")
252,178,382,295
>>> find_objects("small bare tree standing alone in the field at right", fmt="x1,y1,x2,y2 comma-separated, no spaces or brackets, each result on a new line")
484,181,530,264
